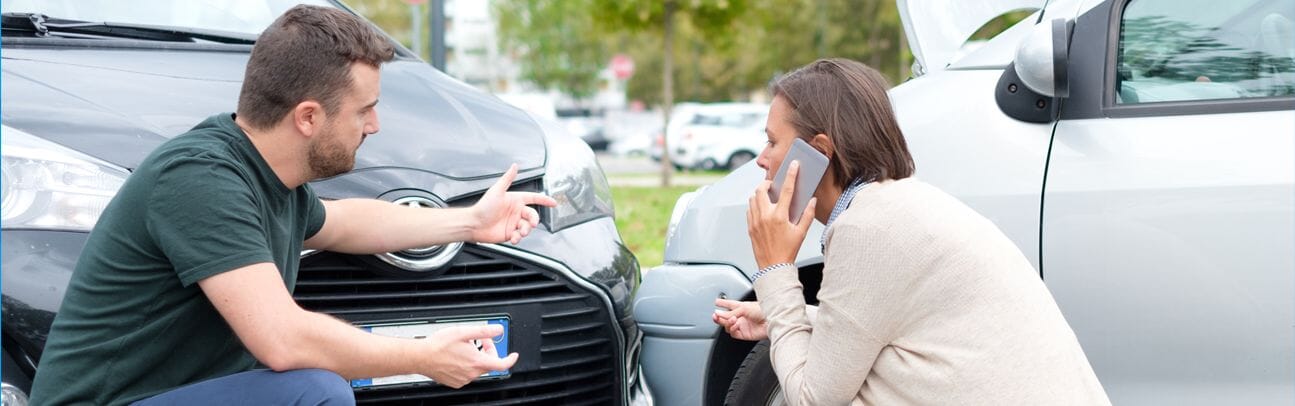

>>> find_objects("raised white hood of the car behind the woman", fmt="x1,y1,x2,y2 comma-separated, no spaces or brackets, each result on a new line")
897,0,1046,76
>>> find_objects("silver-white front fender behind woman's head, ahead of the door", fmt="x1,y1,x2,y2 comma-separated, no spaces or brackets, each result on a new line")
891,70,1053,269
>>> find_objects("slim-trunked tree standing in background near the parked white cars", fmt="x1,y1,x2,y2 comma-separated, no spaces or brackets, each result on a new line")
592,0,746,186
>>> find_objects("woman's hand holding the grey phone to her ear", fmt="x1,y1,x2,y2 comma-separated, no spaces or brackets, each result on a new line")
746,162,818,269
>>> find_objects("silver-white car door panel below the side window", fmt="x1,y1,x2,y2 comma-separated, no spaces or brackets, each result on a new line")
1042,109,1295,405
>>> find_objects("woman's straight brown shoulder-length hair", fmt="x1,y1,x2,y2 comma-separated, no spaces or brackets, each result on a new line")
771,58,916,187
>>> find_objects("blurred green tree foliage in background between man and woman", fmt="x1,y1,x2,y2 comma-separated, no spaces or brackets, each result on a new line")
497,0,912,105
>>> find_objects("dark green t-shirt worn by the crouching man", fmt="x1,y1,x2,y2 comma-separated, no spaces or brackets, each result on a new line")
31,114,324,405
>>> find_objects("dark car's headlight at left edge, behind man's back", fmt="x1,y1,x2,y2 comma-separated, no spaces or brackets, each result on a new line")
0,125,130,231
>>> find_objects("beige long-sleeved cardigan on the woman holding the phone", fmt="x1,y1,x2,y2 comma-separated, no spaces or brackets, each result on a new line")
755,178,1110,405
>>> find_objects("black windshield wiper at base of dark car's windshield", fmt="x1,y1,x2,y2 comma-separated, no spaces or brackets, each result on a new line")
0,13,256,45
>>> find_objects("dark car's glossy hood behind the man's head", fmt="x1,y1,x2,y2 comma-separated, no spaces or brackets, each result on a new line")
0,45,545,178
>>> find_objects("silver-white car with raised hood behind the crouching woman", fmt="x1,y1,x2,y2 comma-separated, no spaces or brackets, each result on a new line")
635,0,1295,405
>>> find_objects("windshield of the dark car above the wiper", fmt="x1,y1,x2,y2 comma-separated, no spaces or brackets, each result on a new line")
0,0,334,35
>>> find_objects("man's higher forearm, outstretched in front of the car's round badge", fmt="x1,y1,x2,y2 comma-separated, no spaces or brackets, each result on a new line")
315,199,474,253
